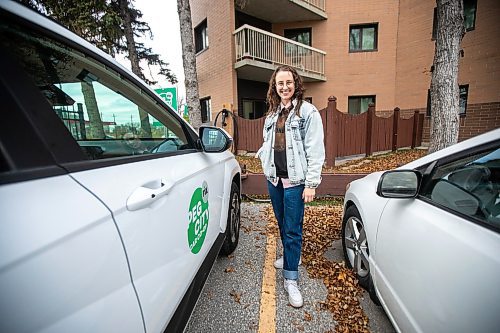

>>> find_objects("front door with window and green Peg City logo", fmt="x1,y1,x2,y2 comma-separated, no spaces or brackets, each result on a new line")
0,11,228,332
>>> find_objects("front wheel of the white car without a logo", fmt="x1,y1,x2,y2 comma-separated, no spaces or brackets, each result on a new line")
342,205,380,305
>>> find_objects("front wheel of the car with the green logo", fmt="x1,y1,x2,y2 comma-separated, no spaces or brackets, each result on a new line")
221,182,240,255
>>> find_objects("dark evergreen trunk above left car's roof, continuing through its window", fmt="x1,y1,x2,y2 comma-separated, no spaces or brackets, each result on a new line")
119,0,152,138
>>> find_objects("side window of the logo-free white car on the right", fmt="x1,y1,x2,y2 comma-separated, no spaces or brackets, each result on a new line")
421,148,500,229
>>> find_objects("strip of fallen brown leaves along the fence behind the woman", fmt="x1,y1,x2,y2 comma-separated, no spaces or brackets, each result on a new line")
236,149,427,173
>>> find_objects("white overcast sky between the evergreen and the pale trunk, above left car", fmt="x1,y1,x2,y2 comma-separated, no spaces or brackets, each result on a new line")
117,0,186,101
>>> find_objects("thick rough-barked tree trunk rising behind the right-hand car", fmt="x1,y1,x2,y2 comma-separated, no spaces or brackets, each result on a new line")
429,0,465,153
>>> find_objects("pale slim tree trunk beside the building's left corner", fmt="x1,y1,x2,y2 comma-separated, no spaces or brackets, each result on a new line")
177,0,201,130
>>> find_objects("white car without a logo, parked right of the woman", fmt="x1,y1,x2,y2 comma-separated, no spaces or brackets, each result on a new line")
342,129,500,332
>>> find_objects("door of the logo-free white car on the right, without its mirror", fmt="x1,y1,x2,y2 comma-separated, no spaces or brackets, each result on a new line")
376,142,500,332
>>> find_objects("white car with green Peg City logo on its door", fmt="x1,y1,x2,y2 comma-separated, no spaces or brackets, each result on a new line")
0,1,241,333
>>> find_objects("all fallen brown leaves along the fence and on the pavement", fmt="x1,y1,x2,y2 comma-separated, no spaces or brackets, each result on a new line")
250,149,427,333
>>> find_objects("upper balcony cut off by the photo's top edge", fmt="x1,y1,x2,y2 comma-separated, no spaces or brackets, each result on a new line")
236,0,327,23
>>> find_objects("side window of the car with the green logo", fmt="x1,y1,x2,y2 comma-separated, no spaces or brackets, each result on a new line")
0,17,194,159
